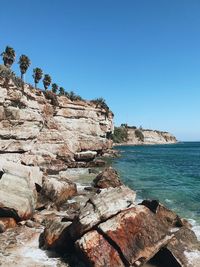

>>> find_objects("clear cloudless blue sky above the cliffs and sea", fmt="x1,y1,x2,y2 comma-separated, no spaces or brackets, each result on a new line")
0,0,200,140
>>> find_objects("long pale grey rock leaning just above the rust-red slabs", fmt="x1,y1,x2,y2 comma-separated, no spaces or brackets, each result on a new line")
71,186,136,239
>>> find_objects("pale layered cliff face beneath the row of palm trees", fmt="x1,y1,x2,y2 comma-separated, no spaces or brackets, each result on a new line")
0,74,113,172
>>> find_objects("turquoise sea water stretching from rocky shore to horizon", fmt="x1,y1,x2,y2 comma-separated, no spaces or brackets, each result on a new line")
112,142,200,224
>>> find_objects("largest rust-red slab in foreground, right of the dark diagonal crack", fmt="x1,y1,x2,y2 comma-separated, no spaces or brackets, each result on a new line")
98,206,173,266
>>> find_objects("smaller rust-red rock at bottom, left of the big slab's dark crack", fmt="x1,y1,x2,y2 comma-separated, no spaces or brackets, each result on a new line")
76,230,125,267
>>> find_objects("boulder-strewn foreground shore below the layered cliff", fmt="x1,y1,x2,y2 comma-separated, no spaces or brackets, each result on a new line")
0,161,200,267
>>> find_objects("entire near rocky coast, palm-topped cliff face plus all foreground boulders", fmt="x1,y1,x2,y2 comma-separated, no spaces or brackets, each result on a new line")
0,71,200,267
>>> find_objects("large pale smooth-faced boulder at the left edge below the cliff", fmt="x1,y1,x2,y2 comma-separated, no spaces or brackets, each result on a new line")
0,161,42,221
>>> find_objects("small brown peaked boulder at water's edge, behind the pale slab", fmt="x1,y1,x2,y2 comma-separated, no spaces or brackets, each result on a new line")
93,167,122,188
